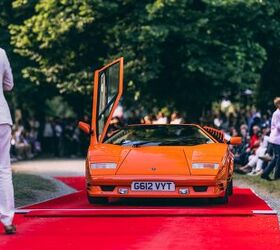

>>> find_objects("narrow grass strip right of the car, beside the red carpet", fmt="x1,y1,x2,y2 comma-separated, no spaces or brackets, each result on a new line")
234,173,280,197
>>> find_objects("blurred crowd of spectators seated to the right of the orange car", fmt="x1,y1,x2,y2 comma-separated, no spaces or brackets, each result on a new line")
197,100,278,181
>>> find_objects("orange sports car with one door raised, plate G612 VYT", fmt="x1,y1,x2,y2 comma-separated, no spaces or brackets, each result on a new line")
79,58,241,203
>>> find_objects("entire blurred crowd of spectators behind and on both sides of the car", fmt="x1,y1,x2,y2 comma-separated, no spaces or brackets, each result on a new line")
11,101,278,182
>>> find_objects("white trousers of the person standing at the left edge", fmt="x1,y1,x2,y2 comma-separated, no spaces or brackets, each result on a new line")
0,124,15,226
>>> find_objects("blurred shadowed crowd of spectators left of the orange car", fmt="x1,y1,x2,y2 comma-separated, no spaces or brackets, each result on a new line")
11,116,89,161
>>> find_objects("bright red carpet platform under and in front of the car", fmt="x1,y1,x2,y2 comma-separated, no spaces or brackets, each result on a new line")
0,178,280,250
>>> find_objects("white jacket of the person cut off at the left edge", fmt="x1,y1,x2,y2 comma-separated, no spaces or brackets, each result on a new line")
0,48,14,125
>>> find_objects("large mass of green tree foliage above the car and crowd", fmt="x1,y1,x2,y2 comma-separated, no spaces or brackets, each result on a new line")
1,0,280,117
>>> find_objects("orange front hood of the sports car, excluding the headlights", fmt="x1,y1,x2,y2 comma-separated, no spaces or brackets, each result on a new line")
88,143,227,175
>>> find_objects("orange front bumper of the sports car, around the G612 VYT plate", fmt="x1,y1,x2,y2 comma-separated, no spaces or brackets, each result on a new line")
87,175,227,198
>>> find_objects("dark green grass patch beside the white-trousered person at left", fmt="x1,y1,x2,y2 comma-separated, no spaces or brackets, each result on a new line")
13,173,56,207
